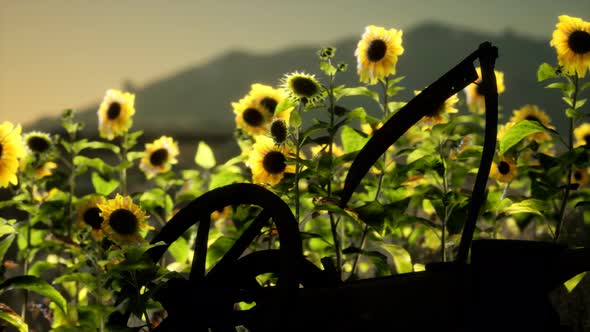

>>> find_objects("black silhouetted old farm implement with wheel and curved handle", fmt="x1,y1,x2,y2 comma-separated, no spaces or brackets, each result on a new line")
133,42,590,332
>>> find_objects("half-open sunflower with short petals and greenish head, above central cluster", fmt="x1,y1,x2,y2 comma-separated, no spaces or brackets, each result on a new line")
281,72,322,104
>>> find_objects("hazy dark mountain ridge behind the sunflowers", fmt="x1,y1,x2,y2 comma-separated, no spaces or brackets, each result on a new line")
30,22,565,159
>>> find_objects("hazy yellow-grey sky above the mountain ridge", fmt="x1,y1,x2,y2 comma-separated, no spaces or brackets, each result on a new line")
0,0,590,123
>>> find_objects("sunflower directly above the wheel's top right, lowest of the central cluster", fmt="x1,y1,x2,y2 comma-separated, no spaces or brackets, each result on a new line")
248,135,295,185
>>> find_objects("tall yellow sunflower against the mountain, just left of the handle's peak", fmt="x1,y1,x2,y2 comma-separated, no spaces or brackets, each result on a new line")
354,25,404,84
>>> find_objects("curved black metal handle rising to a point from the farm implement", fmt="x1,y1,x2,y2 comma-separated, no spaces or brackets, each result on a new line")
339,42,498,262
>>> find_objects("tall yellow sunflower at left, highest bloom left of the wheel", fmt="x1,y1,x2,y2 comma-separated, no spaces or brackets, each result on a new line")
98,89,135,140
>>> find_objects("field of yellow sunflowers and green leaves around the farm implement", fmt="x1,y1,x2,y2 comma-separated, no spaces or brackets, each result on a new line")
0,15,590,332
